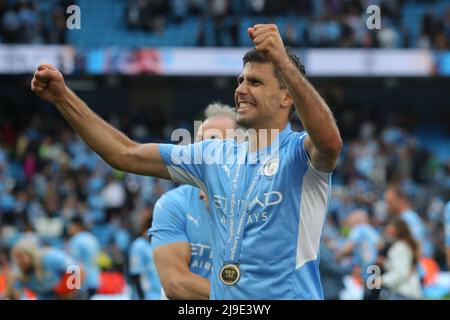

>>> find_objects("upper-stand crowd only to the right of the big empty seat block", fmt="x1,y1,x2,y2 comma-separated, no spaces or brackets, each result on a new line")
126,0,450,50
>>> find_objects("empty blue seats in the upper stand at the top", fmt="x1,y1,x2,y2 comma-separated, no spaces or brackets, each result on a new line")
65,0,450,48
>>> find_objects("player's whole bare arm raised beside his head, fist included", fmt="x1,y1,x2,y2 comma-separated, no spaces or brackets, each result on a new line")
248,24,342,171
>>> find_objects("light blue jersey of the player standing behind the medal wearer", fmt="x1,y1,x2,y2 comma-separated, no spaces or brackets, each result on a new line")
149,185,212,280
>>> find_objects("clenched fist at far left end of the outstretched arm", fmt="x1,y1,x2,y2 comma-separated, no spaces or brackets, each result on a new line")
31,64,67,103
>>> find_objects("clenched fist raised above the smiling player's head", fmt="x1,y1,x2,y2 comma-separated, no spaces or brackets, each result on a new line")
247,24,288,66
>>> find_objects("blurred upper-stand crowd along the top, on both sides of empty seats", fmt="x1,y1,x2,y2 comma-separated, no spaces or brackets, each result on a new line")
0,0,450,50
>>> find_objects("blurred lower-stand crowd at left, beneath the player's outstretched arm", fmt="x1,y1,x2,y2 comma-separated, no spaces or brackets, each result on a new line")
0,104,173,295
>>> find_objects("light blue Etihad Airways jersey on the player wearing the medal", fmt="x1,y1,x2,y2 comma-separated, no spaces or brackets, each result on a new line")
159,128,331,299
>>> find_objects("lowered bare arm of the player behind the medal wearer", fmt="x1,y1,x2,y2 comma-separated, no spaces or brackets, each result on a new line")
153,242,210,300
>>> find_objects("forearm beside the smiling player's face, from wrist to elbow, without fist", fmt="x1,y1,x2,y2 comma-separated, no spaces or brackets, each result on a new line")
278,57,342,153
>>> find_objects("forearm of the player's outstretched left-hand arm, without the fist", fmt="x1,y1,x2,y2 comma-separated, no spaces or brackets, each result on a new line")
55,88,135,169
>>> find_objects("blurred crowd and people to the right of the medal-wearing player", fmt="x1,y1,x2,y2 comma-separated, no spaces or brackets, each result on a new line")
322,122,450,299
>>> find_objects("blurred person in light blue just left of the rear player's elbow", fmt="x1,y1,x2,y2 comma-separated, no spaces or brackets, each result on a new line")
129,216,161,300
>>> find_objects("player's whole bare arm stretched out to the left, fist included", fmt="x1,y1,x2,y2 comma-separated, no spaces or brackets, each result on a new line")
31,64,170,179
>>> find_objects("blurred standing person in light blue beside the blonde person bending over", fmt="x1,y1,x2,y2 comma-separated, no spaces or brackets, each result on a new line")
67,217,100,299
